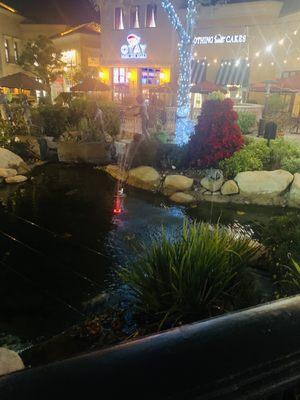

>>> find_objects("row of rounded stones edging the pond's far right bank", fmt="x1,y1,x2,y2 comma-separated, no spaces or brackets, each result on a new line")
100,165,300,208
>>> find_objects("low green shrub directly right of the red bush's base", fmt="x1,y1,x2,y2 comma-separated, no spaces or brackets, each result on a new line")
219,147,263,178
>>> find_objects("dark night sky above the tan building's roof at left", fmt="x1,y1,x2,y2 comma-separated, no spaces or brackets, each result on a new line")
3,0,99,25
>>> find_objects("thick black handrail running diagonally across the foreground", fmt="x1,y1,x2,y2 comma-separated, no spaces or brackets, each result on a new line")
0,296,300,400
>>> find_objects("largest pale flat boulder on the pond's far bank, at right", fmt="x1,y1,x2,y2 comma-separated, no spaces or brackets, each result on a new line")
234,170,294,198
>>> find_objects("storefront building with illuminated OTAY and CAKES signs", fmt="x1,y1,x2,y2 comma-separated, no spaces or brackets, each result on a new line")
101,0,300,113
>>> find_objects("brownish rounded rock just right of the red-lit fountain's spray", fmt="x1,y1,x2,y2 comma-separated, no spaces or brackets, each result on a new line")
127,167,161,191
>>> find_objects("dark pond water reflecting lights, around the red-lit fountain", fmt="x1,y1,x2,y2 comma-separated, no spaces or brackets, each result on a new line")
0,164,283,350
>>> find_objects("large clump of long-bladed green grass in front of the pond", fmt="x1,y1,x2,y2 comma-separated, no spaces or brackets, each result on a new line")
121,222,261,326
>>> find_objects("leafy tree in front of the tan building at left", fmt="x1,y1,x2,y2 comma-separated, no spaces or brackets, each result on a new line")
19,35,65,91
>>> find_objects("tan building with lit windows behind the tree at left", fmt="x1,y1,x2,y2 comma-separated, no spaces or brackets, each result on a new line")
0,2,100,98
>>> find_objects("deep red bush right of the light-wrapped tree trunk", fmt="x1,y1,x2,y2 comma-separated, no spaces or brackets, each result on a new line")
189,99,244,168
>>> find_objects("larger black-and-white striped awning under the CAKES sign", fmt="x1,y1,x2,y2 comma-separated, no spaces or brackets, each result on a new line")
216,59,250,86
